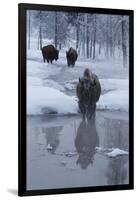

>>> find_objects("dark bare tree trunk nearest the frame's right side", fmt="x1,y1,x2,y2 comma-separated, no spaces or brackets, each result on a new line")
121,17,127,67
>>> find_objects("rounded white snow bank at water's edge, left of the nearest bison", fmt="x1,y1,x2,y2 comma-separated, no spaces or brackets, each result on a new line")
27,86,78,115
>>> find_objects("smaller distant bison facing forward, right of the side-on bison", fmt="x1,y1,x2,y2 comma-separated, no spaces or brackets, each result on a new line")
66,47,78,67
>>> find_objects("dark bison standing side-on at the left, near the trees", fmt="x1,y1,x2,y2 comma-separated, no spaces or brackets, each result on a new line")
41,45,59,63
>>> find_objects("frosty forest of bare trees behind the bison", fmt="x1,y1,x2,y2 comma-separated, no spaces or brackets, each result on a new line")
27,10,129,67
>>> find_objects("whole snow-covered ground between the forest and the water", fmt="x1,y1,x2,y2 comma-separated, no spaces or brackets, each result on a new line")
27,47,129,115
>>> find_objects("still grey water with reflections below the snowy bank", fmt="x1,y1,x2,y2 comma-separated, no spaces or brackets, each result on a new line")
27,111,129,190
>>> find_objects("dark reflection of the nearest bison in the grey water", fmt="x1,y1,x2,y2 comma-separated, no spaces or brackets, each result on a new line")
75,119,99,169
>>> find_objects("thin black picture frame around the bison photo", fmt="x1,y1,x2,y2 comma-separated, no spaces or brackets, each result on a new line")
18,3,134,196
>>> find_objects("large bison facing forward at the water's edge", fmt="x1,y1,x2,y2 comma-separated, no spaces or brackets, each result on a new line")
77,69,101,120
